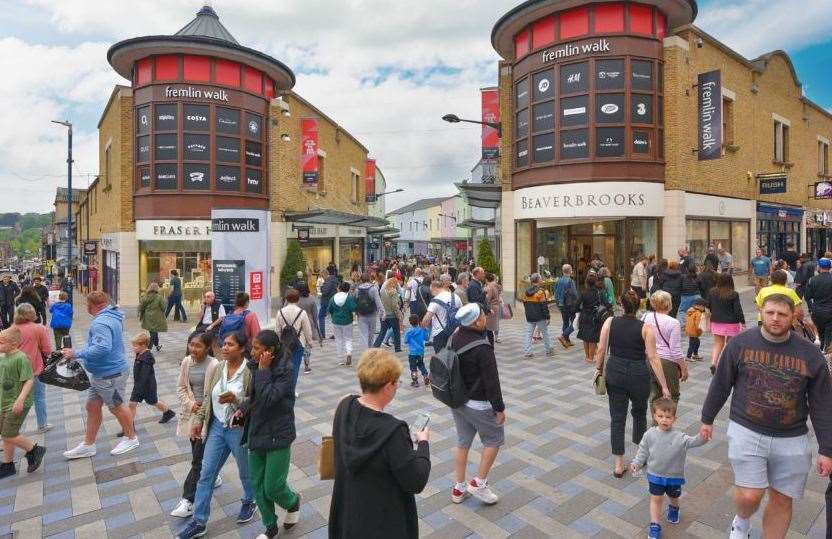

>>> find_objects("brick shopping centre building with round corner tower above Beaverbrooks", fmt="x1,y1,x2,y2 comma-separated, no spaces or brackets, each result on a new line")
491,0,832,295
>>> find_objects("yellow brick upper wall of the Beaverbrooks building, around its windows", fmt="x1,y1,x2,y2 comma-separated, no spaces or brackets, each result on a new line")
664,29,832,208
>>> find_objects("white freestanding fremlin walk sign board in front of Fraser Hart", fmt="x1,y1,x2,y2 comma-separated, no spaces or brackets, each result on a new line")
211,209,272,326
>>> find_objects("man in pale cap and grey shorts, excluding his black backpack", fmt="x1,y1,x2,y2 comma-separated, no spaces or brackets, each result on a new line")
448,303,506,505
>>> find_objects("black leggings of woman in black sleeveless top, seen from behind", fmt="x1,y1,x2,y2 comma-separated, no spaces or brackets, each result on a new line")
604,356,650,455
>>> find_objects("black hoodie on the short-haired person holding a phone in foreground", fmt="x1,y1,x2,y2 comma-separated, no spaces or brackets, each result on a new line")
329,395,430,539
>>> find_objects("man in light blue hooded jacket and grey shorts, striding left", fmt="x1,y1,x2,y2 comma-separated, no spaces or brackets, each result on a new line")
63,291,139,459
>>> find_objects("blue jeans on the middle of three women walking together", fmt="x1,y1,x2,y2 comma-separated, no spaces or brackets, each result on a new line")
194,417,254,524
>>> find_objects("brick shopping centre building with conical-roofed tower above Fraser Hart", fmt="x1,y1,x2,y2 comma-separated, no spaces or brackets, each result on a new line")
77,6,386,308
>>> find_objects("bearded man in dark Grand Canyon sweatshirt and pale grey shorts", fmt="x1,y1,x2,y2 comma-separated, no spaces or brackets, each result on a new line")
700,294,832,539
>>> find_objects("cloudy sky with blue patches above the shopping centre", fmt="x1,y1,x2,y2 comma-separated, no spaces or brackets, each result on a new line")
0,0,832,216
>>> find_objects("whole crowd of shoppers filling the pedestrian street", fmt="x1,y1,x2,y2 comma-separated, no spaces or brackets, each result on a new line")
0,247,832,539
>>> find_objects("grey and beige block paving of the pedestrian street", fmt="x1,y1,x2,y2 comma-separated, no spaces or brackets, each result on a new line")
0,294,827,539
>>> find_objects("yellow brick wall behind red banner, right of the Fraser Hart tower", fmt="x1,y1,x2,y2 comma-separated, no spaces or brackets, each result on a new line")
269,93,367,220
